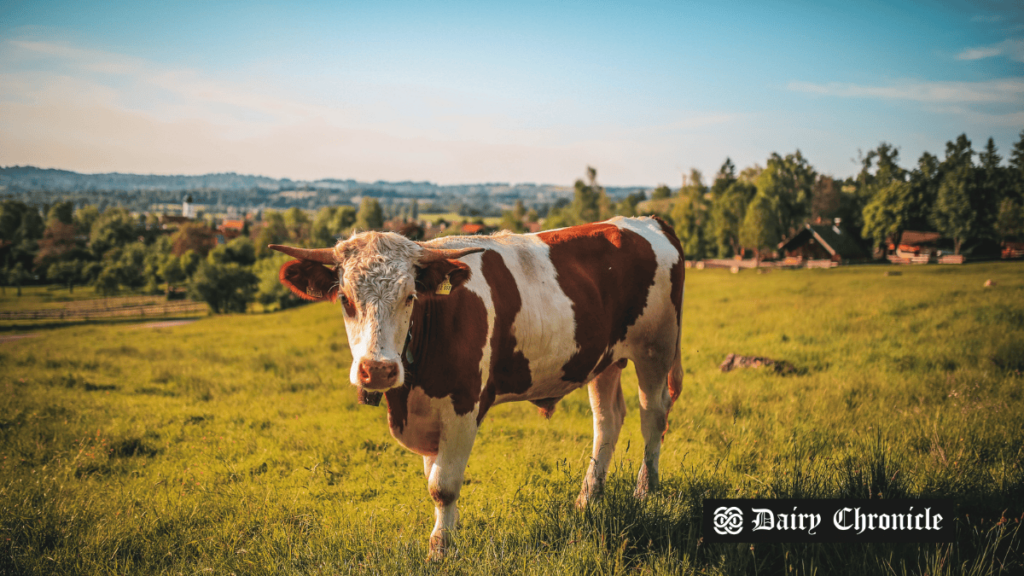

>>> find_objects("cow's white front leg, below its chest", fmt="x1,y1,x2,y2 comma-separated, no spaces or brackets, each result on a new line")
424,404,477,561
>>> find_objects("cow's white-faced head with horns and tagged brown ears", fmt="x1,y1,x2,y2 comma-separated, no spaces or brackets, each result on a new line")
269,232,483,390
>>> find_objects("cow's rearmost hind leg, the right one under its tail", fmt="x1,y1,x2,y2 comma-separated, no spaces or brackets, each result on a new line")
635,359,672,498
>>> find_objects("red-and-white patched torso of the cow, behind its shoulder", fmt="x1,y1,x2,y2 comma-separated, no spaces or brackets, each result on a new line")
419,218,683,411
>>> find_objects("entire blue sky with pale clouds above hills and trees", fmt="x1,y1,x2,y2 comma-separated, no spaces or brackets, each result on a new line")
0,0,1024,187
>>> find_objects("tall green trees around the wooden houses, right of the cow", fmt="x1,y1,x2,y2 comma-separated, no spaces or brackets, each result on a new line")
545,131,1024,259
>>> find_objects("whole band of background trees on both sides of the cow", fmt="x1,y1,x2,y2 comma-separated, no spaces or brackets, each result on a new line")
0,131,1024,313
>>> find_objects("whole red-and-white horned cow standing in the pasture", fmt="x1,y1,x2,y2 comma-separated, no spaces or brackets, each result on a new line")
269,217,685,560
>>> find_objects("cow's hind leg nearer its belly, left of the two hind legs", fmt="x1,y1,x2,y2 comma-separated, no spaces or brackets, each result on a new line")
575,361,626,508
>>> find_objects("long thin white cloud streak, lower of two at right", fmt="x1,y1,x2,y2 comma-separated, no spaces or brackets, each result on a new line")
787,78,1024,105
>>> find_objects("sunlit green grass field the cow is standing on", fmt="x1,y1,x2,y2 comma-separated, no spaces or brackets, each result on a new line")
0,262,1024,575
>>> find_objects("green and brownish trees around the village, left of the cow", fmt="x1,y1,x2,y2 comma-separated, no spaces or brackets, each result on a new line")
0,198,391,313
